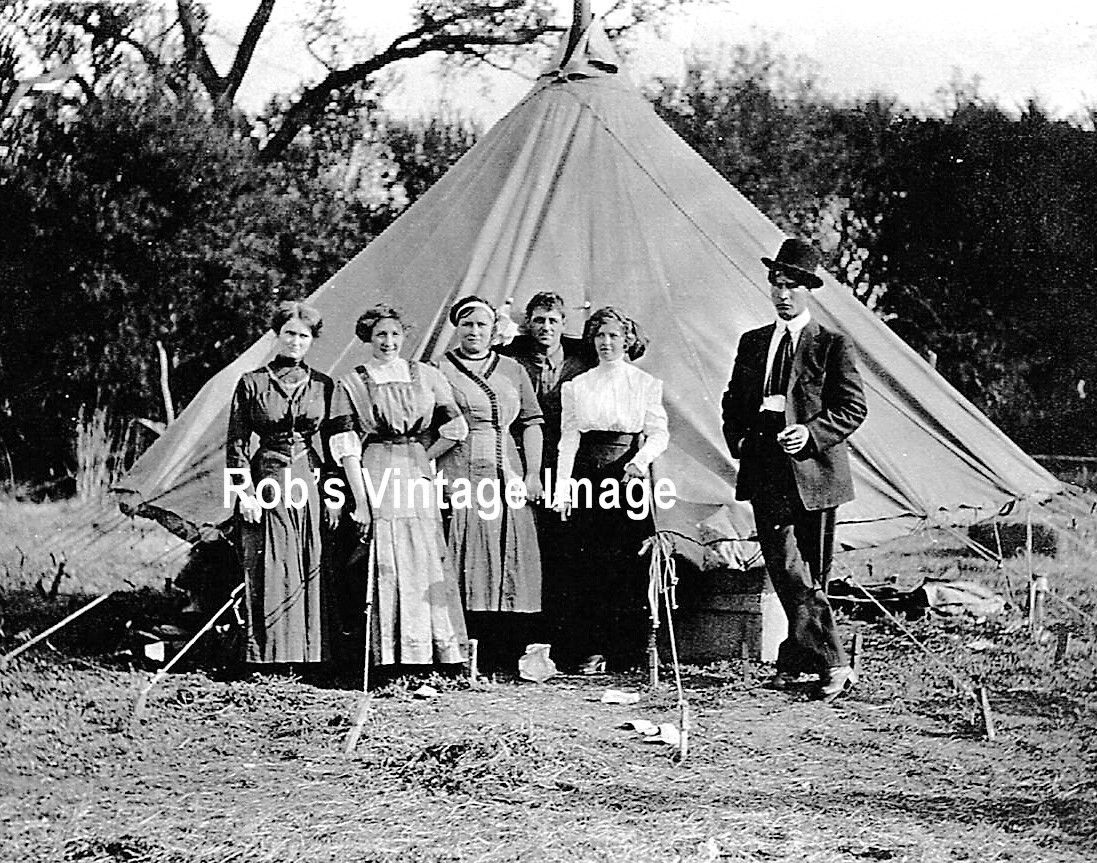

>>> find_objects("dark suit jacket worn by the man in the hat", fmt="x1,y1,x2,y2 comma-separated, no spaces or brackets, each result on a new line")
723,319,868,510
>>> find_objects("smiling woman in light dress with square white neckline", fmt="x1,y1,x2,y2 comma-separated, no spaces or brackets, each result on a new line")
329,305,468,666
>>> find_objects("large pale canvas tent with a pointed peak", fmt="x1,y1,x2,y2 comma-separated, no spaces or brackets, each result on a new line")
113,24,1061,559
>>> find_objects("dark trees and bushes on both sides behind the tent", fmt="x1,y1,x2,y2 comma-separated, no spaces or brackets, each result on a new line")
0,2,1097,490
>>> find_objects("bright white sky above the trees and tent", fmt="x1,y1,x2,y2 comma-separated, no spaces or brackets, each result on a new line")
210,0,1097,123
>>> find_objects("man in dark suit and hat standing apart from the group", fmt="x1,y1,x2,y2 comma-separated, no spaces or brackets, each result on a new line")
723,239,867,701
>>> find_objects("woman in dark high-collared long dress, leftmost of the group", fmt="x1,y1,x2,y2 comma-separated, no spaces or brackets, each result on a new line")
226,302,332,663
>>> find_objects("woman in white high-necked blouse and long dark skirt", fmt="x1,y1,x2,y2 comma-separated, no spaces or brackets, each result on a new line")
554,306,668,672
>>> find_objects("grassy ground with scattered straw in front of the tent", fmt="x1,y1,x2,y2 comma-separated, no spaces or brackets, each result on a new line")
0,507,1097,863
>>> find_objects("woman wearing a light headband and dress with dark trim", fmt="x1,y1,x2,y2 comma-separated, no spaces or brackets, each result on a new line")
438,296,542,670
